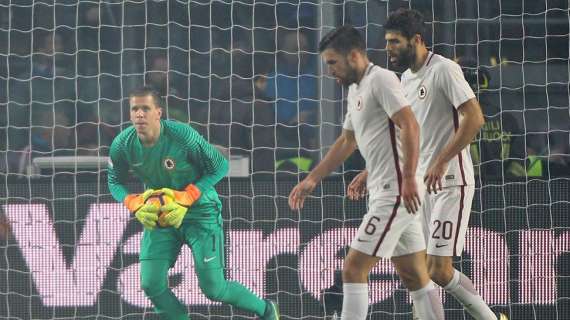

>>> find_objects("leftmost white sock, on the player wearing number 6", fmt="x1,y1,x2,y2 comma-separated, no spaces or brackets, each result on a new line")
340,283,368,320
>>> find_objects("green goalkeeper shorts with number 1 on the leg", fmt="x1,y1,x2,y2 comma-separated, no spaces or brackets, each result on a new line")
139,212,225,269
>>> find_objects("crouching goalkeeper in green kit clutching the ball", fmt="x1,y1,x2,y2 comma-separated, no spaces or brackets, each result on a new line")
108,87,279,319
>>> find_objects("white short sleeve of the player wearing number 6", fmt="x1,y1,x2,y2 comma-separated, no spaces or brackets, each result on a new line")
372,70,410,118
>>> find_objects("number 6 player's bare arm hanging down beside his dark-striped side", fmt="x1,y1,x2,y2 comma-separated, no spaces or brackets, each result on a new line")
391,106,421,213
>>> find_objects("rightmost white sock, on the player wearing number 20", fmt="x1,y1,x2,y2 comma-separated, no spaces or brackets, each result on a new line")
443,270,497,320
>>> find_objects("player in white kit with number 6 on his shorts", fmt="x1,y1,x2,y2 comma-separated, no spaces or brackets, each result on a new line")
289,26,443,320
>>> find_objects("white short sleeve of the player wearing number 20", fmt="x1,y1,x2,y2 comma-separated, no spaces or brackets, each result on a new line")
436,63,475,109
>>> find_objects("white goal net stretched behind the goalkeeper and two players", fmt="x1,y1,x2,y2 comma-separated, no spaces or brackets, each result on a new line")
0,0,570,319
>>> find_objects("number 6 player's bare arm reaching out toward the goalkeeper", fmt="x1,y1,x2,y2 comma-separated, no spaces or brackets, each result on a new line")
289,129,357,210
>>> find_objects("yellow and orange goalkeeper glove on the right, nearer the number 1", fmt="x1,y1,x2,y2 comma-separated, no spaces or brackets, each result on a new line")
160,184,201,228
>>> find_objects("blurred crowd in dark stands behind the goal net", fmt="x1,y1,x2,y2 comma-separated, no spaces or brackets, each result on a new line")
0,1,570,177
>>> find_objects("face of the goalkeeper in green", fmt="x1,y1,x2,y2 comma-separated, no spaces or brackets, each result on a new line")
129,95,162,133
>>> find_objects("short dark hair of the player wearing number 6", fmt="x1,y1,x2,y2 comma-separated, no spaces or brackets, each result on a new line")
319,25,366,54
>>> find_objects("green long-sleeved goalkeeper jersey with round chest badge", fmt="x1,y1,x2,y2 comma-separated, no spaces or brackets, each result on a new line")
108,120,228,221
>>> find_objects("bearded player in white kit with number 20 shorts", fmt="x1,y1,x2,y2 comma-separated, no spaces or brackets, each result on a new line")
348,9,506,320
